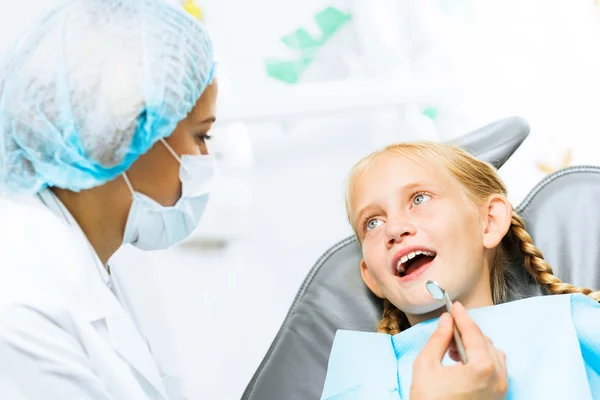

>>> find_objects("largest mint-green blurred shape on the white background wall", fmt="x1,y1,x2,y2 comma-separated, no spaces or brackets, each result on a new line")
266,7,351,84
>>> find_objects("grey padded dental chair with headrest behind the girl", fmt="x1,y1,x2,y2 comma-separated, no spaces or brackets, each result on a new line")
242,118,600,400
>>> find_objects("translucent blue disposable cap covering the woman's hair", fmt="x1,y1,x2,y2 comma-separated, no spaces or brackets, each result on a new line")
0,0,214,193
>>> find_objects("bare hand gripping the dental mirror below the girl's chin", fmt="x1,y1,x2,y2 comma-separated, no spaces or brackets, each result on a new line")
410,303,508,400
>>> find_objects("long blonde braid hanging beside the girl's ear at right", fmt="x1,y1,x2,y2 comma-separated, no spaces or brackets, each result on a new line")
510,211,600,302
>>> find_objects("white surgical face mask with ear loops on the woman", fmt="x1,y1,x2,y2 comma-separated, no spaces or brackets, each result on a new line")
123,139,214,250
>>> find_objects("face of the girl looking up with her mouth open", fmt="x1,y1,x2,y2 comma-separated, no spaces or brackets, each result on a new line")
350,154,510,323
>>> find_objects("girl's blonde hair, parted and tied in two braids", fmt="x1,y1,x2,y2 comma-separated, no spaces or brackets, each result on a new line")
346,142,600,334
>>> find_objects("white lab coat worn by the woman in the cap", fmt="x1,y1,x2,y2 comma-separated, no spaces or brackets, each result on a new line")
0,190,181,400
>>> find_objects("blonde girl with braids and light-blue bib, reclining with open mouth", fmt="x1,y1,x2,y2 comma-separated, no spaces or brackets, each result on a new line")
322,142,600,400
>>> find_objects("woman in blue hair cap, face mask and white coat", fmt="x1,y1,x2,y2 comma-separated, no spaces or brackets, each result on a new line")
0,0,217,400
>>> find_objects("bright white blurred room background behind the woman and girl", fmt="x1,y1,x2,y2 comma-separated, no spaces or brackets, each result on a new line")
0,0,600,400
